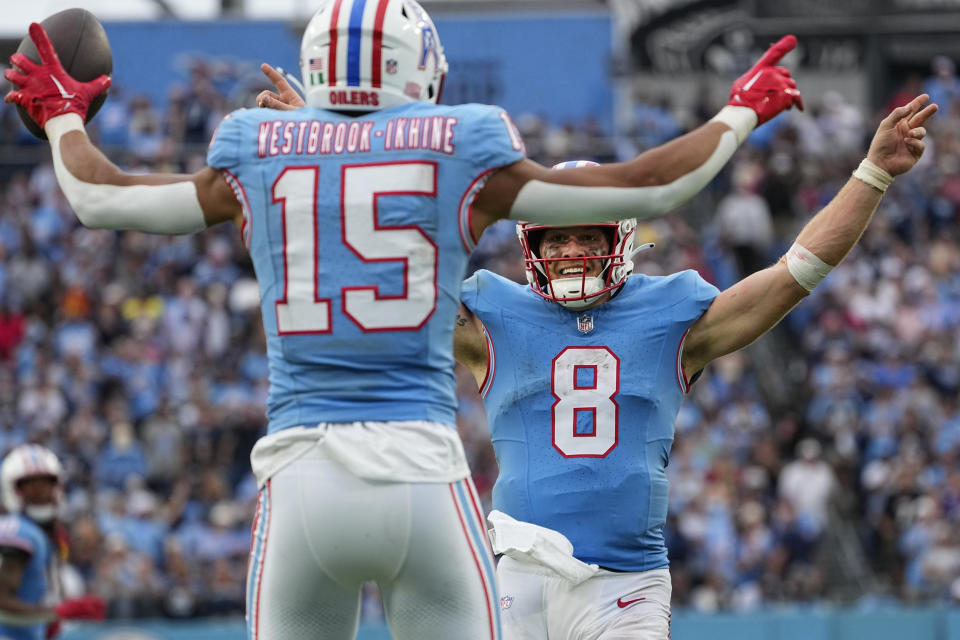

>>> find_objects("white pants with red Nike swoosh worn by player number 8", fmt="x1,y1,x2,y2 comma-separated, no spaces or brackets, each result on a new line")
497,556,672,640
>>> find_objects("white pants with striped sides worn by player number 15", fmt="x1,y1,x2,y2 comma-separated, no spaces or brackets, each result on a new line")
247,447,501,640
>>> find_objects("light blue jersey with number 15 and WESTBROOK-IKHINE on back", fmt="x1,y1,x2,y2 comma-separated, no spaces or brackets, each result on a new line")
207,103,524,433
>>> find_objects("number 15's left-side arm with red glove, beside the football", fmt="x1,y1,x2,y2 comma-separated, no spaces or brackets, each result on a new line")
4,23,243,234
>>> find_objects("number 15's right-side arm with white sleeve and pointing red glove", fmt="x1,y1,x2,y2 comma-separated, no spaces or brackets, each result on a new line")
472,35,803,237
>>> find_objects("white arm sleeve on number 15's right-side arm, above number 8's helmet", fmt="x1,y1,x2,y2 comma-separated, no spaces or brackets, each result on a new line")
510,107,757,225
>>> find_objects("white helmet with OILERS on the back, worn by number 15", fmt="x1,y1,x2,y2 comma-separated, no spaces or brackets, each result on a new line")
300,0,447,111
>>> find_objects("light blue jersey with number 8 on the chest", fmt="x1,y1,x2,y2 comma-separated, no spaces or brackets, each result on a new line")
462,271,718,571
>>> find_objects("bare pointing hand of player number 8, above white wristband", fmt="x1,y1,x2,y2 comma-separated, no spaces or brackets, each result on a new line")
867,93,937,176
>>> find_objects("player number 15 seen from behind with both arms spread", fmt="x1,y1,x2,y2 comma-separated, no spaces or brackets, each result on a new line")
5,0,801,640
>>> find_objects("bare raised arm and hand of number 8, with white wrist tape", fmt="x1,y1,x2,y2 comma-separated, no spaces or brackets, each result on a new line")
682,94,937,374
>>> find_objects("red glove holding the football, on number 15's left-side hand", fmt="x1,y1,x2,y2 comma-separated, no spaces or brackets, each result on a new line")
3,22,110,128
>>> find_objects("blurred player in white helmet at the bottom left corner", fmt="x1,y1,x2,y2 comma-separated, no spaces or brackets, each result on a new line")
0,444,106,640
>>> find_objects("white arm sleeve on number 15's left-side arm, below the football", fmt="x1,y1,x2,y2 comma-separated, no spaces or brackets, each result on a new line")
44,113,207,234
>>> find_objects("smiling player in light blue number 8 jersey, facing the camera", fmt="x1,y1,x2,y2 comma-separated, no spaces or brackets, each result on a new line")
454,95,936,640
